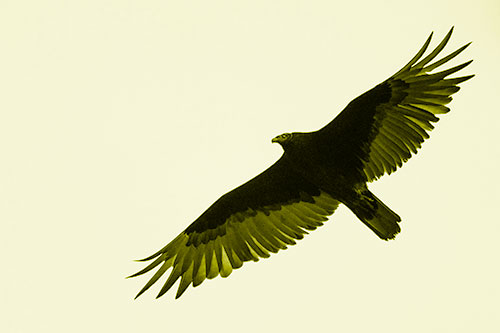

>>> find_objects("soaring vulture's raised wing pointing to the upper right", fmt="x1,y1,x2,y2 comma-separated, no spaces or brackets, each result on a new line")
315,28,474,181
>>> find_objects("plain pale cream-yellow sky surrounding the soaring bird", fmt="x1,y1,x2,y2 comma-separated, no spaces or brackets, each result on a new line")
0,0,500,333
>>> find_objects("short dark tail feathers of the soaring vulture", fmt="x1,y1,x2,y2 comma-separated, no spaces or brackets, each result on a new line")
349,190,401,240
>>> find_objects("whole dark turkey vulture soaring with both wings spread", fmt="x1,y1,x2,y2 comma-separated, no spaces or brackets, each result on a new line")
130,28,473,298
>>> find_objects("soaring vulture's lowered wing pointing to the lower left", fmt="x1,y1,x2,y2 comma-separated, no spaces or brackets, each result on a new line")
131,157,339,298
